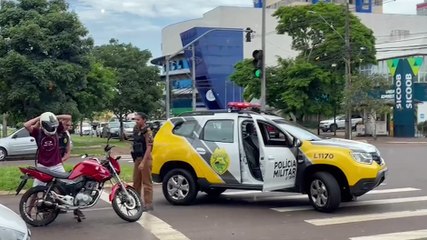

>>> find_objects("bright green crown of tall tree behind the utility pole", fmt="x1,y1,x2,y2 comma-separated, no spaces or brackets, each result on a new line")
273,3,376,73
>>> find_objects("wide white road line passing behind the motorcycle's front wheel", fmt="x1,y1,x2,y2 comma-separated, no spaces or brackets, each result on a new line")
101,192,190,240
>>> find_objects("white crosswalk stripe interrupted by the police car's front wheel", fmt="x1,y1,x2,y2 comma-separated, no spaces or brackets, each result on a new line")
271,196,427,212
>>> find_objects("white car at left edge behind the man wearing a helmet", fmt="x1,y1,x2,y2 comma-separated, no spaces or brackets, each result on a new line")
0,128,37,161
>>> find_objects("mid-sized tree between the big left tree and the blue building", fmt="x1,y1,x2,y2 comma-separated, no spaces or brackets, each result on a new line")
94,39,161,140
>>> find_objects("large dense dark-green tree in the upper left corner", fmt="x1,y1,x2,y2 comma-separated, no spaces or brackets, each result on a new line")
0,0,93,120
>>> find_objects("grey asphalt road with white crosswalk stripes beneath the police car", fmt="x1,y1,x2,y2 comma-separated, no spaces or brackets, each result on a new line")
0,143,427,240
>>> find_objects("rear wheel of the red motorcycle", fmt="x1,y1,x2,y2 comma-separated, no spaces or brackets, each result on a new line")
19,186,59,227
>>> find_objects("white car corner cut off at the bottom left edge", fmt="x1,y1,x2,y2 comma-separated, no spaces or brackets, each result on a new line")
0,204,31,240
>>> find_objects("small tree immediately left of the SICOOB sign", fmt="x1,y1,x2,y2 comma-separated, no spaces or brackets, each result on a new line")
344,74,391,139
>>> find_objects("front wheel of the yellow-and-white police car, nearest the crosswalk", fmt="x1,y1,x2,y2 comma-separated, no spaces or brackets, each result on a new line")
308,172,341,212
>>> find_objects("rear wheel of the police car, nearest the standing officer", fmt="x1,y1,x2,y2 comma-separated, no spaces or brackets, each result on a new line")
163,169,198,205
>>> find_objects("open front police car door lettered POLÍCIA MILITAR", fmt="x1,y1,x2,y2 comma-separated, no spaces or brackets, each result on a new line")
252,115,297,191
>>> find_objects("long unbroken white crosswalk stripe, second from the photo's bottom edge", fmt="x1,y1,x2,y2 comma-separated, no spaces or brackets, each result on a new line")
304,209,427,226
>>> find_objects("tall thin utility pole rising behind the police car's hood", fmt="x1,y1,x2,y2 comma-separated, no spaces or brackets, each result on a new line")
345,0,352,139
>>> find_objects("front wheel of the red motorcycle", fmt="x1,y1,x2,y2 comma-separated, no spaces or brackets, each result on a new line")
111,188,144,222
